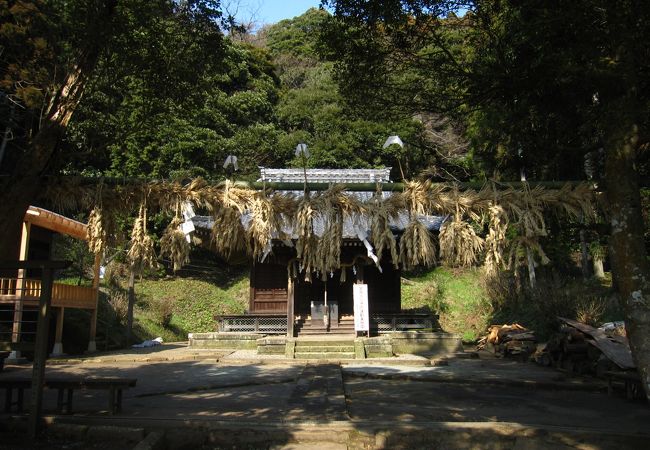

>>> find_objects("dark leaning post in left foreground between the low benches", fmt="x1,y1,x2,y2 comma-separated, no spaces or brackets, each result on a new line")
28,267,54,438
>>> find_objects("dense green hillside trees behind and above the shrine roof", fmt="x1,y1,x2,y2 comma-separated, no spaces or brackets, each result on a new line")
16,4,466,179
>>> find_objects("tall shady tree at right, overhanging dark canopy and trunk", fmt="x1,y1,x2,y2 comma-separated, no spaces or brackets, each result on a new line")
324,0,650,398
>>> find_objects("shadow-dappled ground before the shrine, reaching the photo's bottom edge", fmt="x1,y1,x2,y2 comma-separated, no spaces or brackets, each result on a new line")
0,345,650,448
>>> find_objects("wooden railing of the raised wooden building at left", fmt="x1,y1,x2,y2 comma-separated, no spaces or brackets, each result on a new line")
0,278,97,309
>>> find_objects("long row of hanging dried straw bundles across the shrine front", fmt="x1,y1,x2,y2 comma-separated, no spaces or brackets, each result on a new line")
42,178,595,279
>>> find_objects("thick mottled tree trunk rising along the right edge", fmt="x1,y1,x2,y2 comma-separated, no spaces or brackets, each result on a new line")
605,120,650,399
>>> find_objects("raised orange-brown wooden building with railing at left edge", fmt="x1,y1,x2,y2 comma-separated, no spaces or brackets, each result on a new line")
0,206,101,358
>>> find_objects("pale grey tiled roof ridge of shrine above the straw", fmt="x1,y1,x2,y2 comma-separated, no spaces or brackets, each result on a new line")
257,167,391,184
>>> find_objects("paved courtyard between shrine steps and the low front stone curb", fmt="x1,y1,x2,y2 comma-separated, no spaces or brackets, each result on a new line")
0,346,650,448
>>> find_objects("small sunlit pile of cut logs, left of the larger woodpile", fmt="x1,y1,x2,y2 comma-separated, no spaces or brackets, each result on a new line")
476,323,537,359
